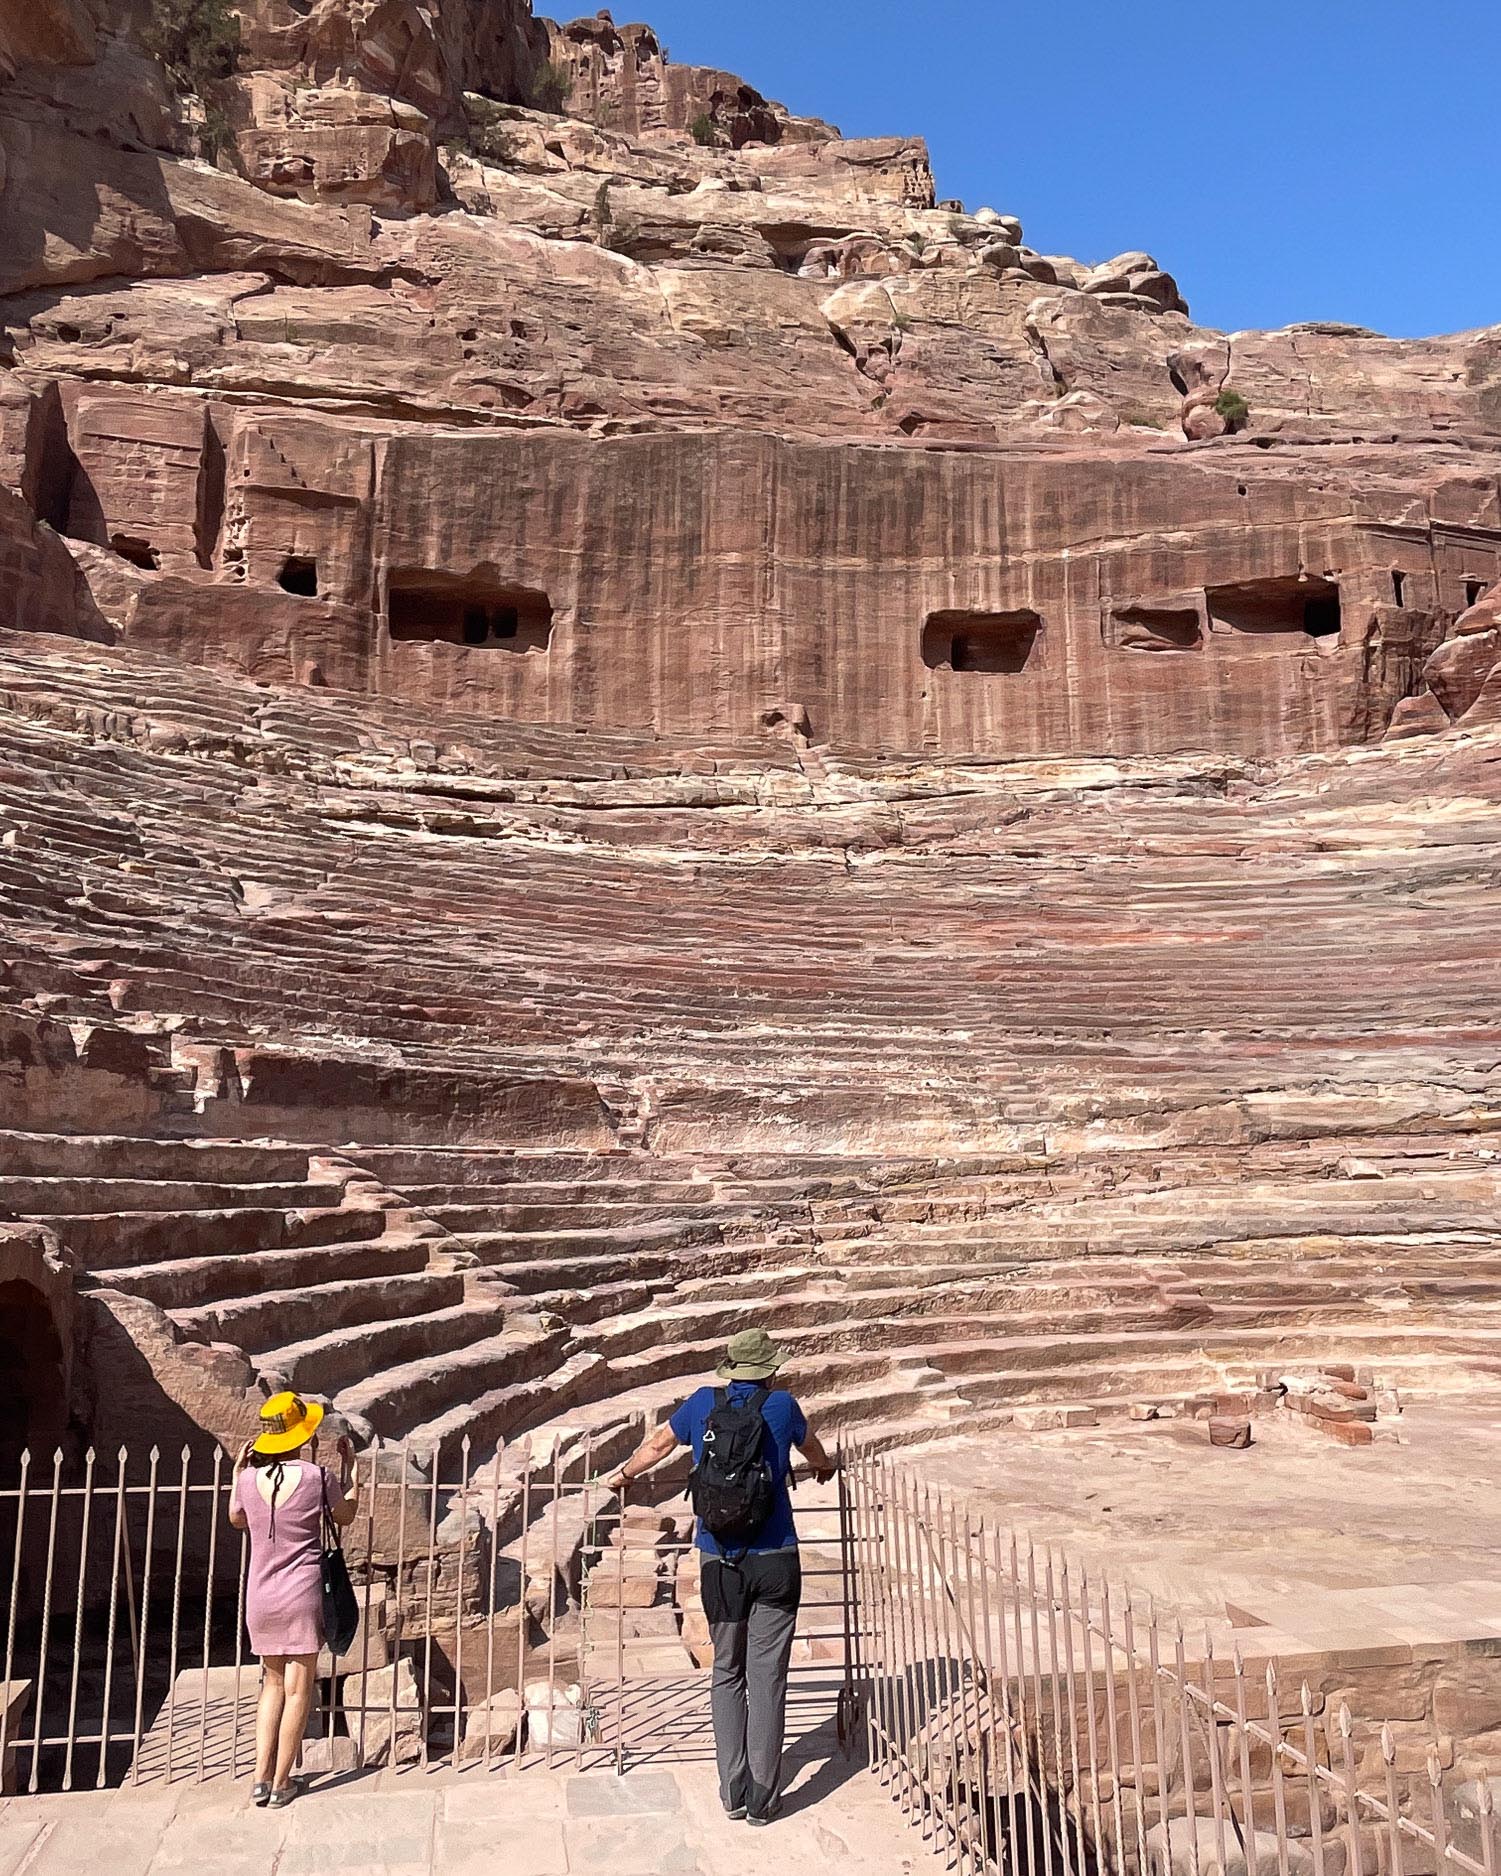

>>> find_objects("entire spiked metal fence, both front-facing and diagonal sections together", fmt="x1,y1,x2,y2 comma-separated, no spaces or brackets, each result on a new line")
0,1424,1501,1876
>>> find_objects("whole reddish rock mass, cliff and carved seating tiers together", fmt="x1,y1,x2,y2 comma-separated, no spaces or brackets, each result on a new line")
0,0,1501,1456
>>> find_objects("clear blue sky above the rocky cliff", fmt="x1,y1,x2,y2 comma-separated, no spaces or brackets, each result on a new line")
637,0,1501,336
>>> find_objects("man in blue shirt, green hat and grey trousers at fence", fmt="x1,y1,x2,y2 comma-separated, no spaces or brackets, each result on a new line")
604,1328,833,1823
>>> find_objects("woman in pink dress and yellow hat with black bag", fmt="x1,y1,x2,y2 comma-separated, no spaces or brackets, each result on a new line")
229,1394,358,1808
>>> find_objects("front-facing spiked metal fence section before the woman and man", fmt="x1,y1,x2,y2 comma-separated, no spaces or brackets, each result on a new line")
0,1422,852,1792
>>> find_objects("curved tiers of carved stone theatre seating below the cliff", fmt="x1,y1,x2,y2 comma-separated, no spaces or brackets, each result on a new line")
0,634,1501,1458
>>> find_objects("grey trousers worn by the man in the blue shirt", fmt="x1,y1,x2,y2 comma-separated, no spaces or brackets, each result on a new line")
704,1550,803,1814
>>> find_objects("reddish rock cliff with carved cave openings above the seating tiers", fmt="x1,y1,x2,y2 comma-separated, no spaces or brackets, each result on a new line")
0,0,1501,754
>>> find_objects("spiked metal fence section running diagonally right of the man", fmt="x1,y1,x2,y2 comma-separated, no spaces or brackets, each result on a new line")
842,1454,1501,1876
